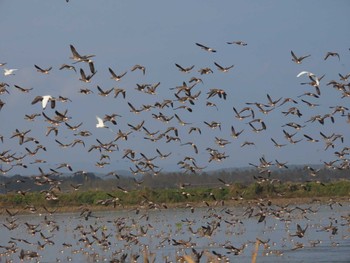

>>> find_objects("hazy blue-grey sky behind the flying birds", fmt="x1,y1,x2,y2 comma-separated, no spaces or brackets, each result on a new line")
0,0,350,175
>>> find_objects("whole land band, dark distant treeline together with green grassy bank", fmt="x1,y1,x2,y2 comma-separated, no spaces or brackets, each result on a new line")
0,167,350,213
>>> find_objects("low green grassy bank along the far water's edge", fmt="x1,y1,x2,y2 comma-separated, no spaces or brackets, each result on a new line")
0,180,350,212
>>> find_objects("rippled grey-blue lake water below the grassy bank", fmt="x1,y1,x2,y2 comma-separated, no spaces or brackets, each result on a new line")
0,203,350,262
